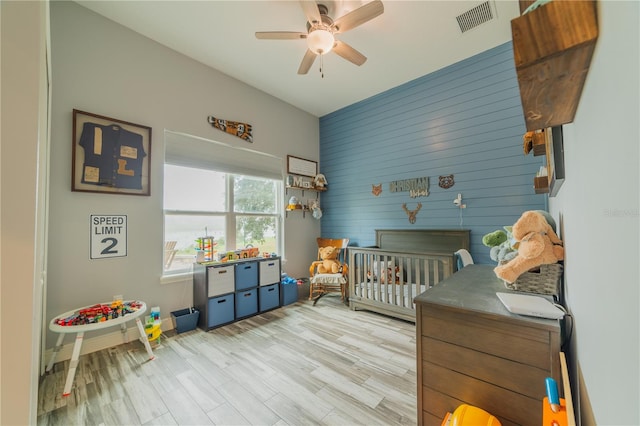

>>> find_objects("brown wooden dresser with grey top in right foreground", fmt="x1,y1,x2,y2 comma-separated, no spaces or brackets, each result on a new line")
415,265,561,426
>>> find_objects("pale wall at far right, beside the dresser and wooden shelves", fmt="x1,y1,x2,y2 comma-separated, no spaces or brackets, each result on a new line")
549,1,640,425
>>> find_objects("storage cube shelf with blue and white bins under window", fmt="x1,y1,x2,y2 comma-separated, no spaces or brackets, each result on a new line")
193,257,282,331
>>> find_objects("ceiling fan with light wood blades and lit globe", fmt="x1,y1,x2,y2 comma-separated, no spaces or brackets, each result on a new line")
256,0,384,74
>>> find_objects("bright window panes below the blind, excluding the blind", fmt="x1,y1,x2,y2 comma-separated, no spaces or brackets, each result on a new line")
164,164,282,274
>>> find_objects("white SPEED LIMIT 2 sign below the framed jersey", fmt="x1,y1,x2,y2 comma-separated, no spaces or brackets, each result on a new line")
89,214,127,259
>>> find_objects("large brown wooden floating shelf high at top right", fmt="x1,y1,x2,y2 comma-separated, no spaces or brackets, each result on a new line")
511,0,598,131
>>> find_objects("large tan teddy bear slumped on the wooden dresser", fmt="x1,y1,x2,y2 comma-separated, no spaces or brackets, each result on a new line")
494,210,564,283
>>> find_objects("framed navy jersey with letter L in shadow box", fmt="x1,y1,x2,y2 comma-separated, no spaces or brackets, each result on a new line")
71,109,151,196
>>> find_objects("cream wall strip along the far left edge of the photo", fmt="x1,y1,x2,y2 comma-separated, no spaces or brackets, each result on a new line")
0,1,47,425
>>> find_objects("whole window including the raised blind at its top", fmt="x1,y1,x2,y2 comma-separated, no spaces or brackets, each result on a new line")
164,132,284,275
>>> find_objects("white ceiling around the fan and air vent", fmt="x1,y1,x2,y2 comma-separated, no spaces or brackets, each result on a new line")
78,0,519,117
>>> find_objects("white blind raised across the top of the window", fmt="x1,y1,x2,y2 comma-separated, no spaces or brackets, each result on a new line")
164,130,284,180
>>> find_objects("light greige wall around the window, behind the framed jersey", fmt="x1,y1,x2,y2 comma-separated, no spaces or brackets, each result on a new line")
47,2,319,347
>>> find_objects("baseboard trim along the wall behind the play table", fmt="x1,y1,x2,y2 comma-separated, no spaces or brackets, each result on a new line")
45,318,174,363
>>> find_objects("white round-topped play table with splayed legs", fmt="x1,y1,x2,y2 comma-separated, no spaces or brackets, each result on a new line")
46,300,154,396
